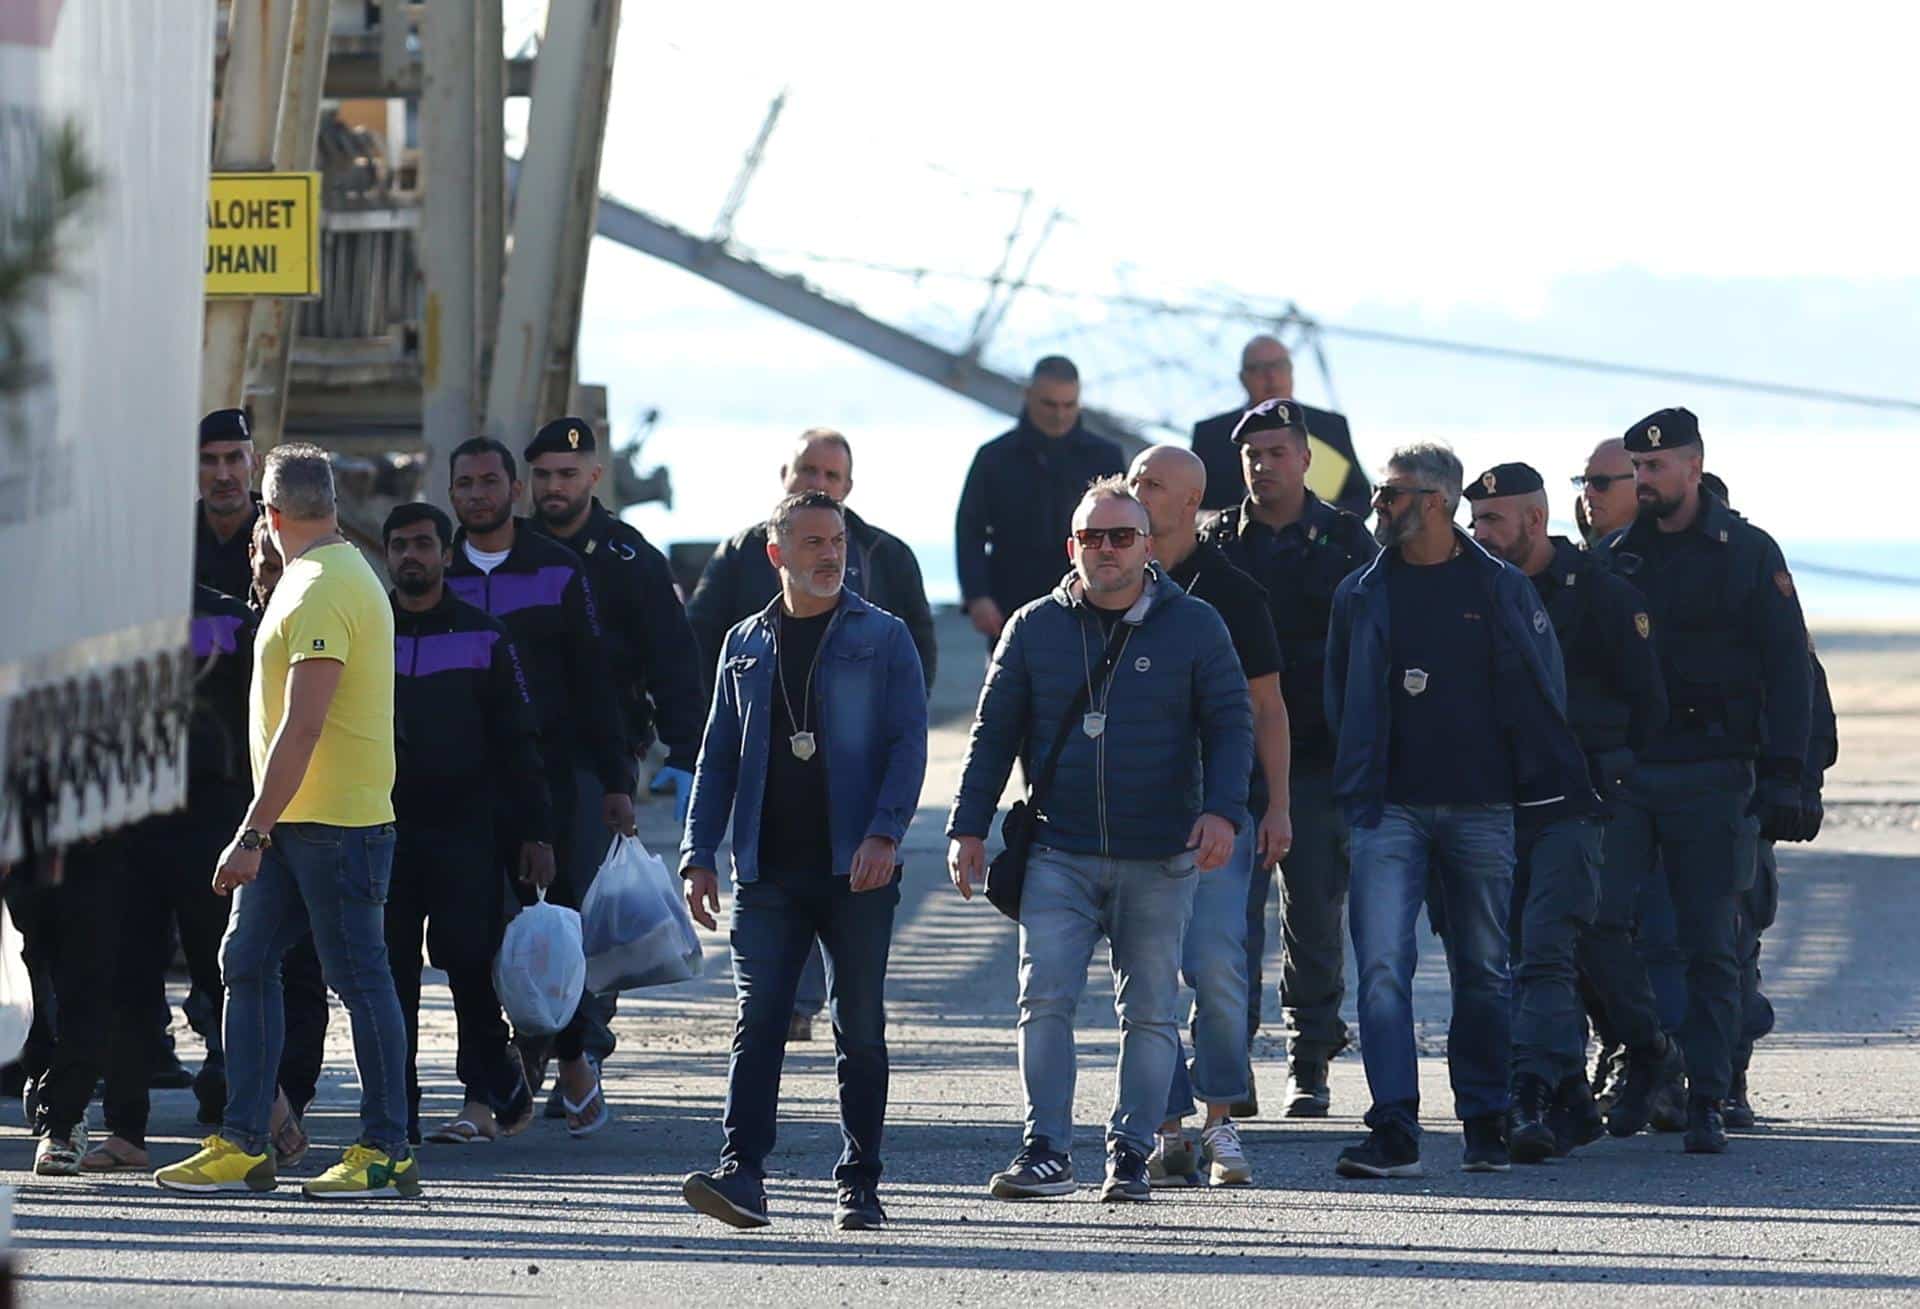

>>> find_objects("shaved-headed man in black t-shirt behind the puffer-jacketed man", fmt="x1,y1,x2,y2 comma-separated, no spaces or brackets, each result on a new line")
1127,445,1294,1186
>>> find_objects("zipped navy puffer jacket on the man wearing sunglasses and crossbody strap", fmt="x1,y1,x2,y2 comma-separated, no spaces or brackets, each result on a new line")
947,568,1254,860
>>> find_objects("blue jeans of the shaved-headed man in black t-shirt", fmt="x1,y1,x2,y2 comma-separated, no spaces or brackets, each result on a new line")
1167,823,1256,1119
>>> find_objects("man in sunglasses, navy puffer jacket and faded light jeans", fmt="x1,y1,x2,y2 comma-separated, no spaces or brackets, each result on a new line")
947,478,1254,1202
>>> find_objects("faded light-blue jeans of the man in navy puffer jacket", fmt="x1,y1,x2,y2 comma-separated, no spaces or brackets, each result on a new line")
1020,845,1213,1155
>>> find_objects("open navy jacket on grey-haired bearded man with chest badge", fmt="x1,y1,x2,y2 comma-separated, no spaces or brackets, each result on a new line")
1327,528,1599,827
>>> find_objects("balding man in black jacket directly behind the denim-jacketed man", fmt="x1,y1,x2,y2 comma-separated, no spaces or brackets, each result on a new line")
687,428,941,691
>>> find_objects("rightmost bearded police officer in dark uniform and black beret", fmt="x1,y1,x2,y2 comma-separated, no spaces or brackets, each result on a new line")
1596,409,1812,1154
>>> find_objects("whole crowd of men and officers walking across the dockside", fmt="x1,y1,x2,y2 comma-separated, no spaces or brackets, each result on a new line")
6,336,1837,1228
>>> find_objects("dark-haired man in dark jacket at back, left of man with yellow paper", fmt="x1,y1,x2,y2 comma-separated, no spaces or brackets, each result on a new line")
954,355,1127,643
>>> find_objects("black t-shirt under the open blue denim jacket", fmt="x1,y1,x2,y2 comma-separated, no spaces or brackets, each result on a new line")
760,605,839,881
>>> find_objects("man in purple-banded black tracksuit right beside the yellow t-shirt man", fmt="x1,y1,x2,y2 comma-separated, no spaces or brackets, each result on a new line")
382,503,553,1146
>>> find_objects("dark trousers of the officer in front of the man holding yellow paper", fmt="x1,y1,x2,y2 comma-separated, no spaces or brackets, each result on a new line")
1246,762,1348,1059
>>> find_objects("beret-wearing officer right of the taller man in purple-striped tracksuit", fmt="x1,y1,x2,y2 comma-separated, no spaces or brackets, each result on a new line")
526,417,707,818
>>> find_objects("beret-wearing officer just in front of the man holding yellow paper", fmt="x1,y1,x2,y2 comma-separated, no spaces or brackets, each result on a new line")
1202,399,1379,1117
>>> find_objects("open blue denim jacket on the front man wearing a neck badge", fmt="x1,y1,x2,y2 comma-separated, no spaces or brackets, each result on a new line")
680,591,927,883
